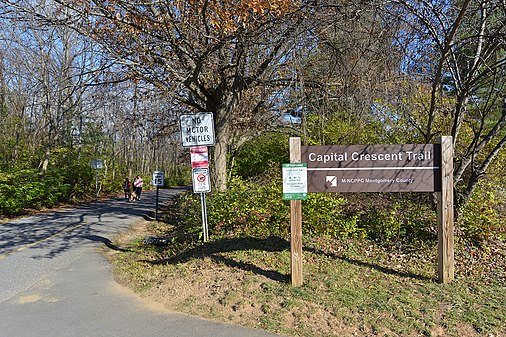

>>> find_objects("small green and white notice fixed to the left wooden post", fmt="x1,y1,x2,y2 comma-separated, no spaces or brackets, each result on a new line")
282,163,307,200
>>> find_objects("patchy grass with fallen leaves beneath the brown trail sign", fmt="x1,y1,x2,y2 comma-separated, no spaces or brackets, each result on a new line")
109,222,506,337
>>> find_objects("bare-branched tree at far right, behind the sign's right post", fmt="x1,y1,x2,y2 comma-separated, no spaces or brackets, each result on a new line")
395,0,506,209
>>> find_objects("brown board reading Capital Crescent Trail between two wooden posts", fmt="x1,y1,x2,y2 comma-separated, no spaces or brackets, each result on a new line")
301,144,441,192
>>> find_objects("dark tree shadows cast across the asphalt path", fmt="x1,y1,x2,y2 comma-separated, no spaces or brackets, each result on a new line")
0,188,184,259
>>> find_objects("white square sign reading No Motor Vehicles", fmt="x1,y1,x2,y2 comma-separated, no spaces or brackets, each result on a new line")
179,112,214,147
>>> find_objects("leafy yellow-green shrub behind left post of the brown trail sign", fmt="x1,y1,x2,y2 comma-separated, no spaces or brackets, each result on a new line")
208,173,365,238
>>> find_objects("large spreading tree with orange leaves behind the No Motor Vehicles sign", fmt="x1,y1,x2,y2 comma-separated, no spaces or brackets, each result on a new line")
11,0,305,190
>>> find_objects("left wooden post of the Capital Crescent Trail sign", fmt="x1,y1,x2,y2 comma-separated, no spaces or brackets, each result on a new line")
290,137,302,287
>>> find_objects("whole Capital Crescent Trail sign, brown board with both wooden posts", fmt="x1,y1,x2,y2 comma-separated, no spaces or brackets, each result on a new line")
290,136,455,286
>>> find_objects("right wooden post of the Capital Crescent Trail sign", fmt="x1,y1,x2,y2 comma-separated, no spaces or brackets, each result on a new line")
437,136,455,284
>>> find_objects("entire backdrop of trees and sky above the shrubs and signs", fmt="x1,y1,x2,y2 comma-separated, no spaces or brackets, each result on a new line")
0,0,506,217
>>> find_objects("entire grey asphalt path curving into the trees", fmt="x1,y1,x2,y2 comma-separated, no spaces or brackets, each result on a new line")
0,189,276,337
